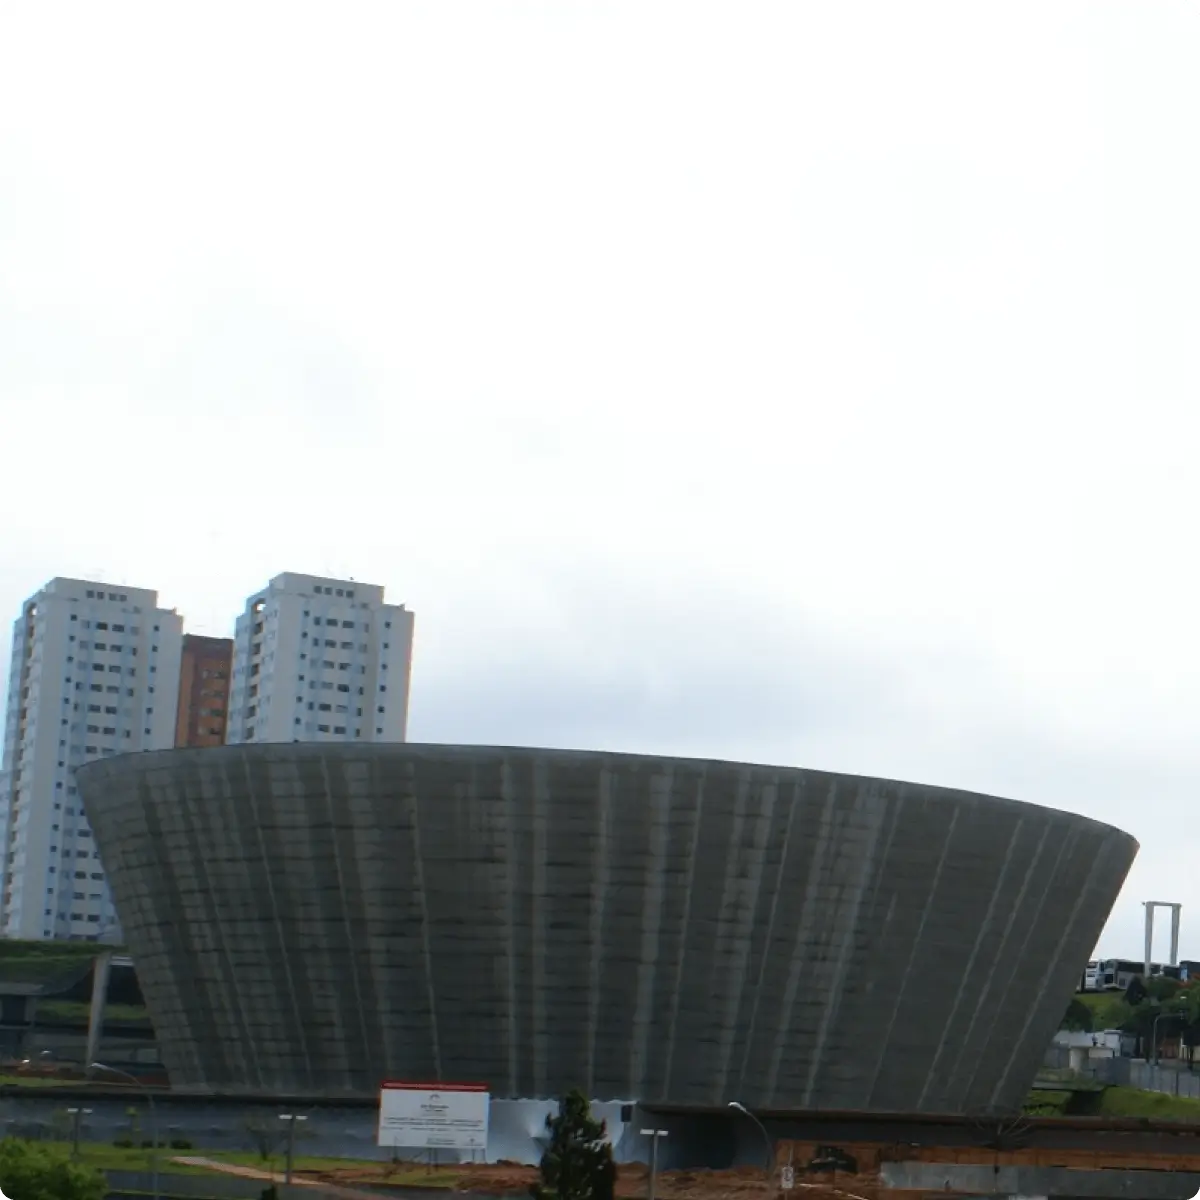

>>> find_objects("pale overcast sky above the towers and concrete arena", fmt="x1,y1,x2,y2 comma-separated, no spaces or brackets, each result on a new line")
0,0,1200,958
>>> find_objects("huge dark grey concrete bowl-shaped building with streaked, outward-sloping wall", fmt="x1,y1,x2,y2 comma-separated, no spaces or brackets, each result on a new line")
78,744,1136,1114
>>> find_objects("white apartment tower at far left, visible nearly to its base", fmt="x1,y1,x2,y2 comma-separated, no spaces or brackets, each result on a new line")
0,578,182,940
